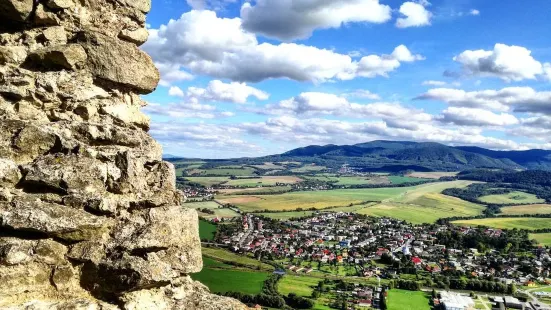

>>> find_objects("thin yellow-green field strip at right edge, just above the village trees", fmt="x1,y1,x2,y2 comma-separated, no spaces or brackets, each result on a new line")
452,217,551,230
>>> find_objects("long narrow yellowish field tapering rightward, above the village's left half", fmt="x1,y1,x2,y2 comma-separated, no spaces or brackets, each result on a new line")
218,187,412,211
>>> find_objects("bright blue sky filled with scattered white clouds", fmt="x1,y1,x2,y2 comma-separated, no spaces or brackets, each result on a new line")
142,0,551,158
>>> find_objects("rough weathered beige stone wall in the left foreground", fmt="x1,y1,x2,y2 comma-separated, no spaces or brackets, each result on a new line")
0,0,243,309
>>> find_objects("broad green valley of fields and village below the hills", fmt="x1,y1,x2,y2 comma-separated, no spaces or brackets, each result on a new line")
166,142,551,310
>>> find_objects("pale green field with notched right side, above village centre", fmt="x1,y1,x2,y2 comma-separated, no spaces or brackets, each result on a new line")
357,181,484,224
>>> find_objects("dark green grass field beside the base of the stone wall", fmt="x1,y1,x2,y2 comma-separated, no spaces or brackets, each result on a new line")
191,267,269,294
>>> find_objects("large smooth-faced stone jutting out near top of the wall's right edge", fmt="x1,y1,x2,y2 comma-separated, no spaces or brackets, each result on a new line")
80,32,160,94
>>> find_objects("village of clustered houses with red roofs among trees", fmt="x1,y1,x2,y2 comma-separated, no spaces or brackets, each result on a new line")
217,212,551,310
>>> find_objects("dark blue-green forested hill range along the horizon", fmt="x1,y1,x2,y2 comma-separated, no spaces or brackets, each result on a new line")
267,141,551,171
